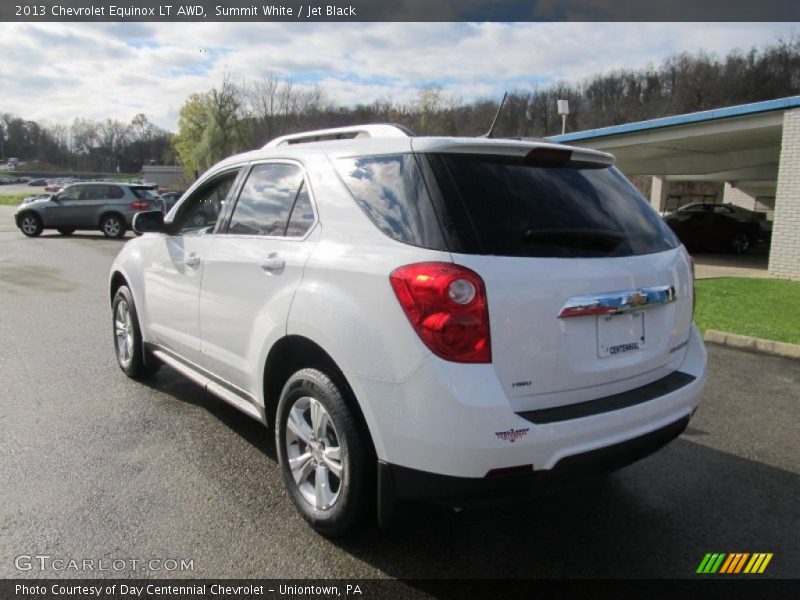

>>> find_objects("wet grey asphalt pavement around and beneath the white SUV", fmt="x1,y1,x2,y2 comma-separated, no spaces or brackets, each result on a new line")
0,217,800,579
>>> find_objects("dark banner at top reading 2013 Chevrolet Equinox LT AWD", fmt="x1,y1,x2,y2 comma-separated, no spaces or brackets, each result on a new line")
0,0,800,22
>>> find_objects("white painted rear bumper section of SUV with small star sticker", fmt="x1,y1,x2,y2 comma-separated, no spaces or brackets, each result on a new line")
349,328,706,480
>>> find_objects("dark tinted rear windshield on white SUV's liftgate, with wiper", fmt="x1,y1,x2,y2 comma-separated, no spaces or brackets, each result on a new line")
427,154,678,257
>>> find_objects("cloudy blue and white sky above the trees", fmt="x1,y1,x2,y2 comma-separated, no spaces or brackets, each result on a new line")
0,23,800,131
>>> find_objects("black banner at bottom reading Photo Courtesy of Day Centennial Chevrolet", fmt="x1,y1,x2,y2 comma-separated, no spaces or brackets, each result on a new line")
0,577,800,600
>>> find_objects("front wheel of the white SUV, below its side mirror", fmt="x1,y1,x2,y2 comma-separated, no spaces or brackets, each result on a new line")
111,285,161,379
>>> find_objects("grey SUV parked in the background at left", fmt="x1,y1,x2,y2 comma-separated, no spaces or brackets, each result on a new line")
14,182,161,238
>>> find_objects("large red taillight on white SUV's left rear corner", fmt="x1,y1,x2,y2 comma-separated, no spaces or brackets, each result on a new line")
389,262,492,363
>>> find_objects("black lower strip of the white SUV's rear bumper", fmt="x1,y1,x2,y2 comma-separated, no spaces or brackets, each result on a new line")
378,416,689,508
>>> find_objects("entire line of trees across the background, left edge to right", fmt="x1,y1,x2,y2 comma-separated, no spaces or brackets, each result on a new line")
0,39,800,177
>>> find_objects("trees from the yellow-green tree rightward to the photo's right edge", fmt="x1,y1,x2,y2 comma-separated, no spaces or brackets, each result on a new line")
175,39,800,172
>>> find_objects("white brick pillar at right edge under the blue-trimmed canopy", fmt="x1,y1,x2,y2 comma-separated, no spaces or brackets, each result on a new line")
769,109,800,281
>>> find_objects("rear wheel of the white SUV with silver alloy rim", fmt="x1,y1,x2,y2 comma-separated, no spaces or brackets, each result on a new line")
275,369,374,537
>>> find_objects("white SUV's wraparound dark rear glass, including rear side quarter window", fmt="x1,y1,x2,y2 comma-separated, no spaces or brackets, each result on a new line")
340,154,679,258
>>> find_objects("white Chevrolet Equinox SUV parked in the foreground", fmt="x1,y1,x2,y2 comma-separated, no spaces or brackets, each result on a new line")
110,125,706,535
